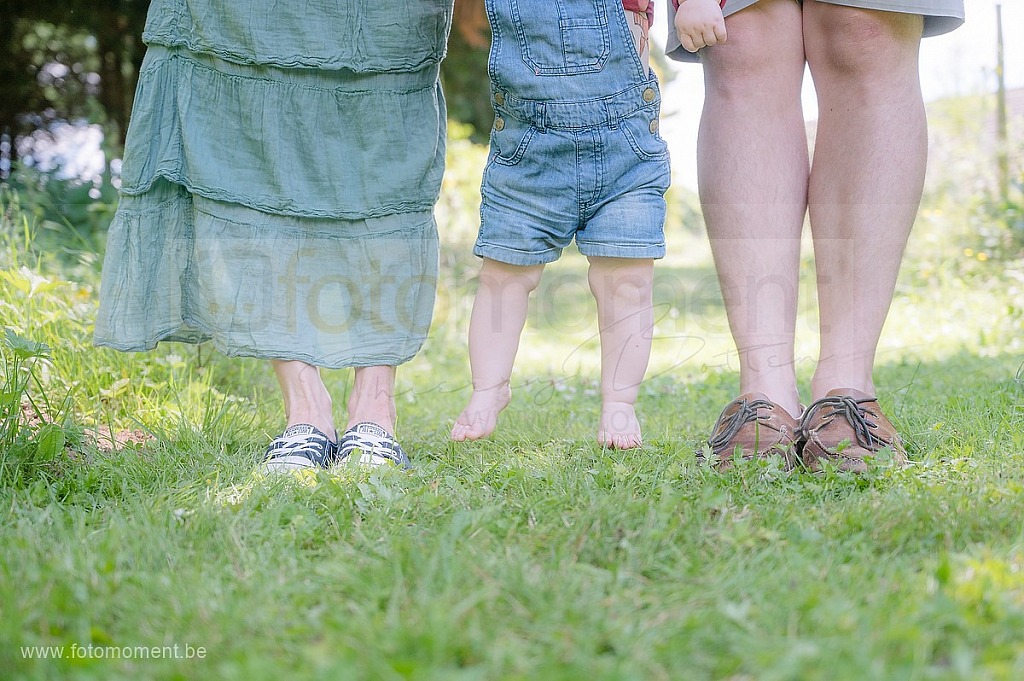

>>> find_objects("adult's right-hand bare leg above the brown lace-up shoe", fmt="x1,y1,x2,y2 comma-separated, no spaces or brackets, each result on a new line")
806,2,928,399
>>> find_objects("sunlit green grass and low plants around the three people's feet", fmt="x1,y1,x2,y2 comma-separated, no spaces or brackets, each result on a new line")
0,123,1024,681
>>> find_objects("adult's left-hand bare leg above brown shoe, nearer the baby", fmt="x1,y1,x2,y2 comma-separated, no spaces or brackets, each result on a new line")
697,0,808,415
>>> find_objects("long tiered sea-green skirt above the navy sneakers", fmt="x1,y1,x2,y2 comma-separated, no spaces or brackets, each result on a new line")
95,0,453,368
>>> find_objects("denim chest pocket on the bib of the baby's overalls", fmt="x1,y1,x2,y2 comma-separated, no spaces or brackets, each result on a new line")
510,0,611,76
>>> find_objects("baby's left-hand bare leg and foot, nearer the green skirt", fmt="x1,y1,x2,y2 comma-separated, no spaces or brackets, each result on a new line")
452,258,544,441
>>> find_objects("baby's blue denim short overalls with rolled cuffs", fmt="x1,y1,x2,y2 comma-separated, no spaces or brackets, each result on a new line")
473,0,670,265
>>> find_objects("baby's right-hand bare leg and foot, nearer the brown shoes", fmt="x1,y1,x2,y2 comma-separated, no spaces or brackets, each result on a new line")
589,257,654,450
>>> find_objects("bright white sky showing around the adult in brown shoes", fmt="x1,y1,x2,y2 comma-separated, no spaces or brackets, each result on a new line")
653,0,1024,188
